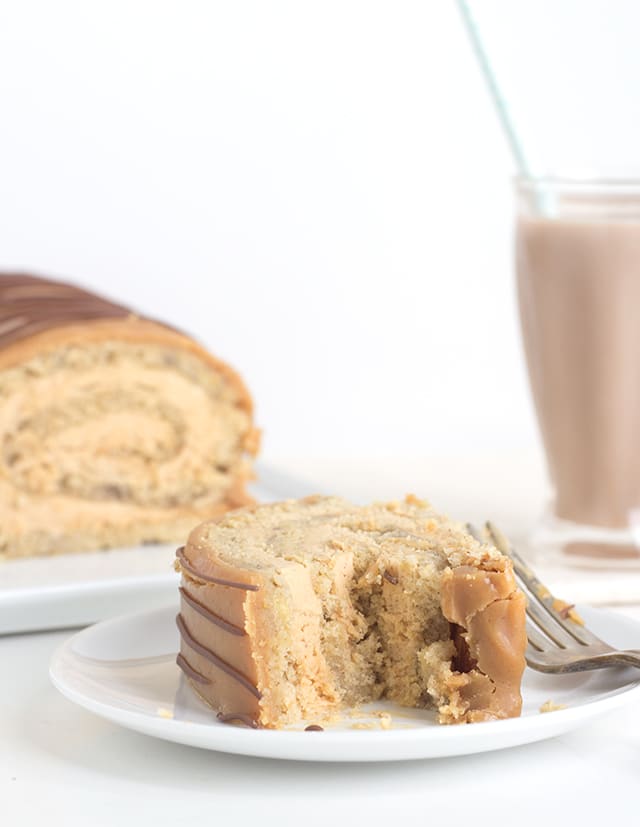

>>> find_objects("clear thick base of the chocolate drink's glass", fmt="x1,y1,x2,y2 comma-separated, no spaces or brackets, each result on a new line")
528,510,640,571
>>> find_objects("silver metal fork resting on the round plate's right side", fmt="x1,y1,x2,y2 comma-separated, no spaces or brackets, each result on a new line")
467,522,640,673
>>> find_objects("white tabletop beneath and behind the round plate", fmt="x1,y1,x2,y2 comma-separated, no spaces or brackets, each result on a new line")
0,458,640,827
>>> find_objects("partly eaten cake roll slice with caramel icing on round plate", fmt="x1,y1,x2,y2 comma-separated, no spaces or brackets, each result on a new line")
176,497,526,728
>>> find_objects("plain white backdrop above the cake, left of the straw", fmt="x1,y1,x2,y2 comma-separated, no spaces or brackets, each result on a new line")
0,0,552,458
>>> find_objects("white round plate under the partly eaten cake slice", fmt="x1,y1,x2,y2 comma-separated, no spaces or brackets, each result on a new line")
50,608,640,761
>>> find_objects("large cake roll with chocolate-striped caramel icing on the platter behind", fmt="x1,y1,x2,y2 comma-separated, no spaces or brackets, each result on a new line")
0,275,257,557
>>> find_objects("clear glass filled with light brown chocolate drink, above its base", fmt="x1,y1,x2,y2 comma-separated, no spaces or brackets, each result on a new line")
516,182,640,560
